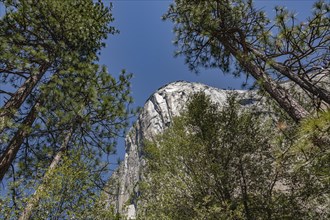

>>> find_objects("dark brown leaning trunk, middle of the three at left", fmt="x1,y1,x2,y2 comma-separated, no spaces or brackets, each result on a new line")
0,102,41,182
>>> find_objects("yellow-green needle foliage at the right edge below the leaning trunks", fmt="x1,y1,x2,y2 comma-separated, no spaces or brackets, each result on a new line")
290,111,330,212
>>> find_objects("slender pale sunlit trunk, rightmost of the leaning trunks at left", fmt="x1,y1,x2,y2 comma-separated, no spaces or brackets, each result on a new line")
19,128,73,220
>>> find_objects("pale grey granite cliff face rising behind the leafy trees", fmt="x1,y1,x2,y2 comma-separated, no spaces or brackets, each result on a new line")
107,81,257,219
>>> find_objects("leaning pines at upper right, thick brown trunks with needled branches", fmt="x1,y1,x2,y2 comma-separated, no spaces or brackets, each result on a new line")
164,0,330,121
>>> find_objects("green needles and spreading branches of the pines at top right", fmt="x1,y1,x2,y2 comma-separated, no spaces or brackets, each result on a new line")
163,0,330,77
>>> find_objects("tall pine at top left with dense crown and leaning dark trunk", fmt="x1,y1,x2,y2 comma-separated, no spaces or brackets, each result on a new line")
0,0,119,179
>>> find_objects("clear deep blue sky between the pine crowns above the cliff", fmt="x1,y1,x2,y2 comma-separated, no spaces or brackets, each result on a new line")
100,0,314,162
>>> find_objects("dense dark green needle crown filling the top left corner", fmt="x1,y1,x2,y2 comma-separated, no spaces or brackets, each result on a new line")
0,0,116,69
